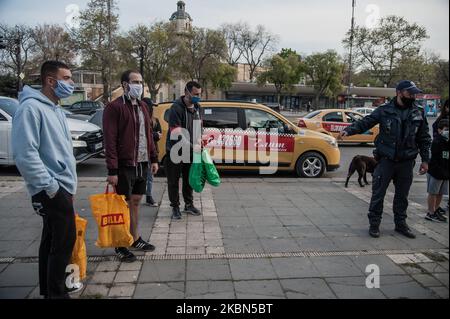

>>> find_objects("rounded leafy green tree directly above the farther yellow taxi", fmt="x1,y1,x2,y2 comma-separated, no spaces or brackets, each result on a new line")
304,50,343,108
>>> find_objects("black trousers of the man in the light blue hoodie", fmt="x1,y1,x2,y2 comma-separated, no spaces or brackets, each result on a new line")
32,187,76,299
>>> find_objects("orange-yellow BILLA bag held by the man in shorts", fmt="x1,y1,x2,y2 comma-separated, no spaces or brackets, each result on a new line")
89,185,134,248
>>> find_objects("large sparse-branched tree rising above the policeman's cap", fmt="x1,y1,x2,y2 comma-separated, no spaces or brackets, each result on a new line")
343,15,428,87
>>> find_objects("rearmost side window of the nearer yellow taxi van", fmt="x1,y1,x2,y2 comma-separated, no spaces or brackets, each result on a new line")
203,107,239,129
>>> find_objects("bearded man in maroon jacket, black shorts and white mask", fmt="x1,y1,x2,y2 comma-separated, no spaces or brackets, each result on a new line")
103,70,158,262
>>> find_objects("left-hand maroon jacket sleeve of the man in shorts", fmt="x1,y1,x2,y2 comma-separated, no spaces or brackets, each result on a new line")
103,104,119,176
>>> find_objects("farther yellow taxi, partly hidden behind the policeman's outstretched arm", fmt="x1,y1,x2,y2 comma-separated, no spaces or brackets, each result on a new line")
297,109,379,143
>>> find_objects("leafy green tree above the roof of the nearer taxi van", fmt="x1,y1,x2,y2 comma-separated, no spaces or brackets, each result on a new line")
257,49,302,103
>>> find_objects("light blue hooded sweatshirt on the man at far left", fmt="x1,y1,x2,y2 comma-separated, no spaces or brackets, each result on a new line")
11,86,77,196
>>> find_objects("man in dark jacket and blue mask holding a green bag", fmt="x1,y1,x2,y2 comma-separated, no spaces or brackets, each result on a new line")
164,81,202,219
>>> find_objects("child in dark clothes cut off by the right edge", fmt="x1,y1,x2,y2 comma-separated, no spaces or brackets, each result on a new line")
425,119,449,222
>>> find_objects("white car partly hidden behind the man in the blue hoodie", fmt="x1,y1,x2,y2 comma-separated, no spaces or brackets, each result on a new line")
0,97,103,165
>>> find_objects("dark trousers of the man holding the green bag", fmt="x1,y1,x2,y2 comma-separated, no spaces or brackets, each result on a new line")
164,156,194,207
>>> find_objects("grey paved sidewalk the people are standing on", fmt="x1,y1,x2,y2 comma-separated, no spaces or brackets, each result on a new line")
0,178,449,299
